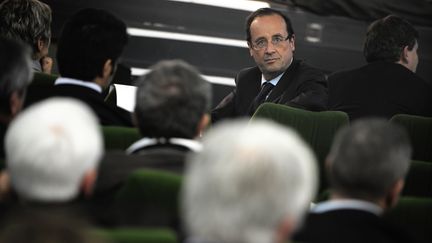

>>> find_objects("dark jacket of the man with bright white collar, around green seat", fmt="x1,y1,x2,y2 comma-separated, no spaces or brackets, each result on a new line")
92,141,190,229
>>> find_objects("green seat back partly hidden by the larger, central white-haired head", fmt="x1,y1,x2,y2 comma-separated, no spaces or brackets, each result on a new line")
251,103,349,191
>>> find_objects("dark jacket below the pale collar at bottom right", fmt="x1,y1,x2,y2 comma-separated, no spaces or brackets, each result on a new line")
293,209,417,243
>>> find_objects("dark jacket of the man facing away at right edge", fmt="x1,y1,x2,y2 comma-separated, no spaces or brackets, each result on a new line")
329,61,432,120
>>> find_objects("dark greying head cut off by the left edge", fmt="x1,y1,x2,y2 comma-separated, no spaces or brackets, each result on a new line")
0,37,33,115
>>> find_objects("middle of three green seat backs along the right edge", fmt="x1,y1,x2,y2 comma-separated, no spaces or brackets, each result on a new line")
402,160,432,198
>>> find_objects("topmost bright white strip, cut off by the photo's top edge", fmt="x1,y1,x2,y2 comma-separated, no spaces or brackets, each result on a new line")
171,0,270,12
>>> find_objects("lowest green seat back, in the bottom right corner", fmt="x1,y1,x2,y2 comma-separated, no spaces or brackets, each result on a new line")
384,197,432,242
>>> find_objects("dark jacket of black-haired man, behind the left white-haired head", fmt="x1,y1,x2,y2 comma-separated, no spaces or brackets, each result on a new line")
50,84,133,127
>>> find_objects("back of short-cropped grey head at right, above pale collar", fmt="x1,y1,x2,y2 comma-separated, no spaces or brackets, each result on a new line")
327,118,411,200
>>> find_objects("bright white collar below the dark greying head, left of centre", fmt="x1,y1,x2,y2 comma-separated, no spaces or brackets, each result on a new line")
126,138,202,154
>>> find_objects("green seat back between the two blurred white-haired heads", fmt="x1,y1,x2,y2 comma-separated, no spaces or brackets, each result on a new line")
114,169,182,229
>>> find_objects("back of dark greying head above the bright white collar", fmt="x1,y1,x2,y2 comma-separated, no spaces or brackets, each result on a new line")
135,60,211,138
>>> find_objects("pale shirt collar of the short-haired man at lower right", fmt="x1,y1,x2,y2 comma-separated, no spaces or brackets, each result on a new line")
311,199,383,215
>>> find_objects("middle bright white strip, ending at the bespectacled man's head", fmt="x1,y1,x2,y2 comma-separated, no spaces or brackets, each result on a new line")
127,28,248,48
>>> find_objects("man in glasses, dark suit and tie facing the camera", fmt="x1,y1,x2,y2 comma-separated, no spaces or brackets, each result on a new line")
212,8,327,121
